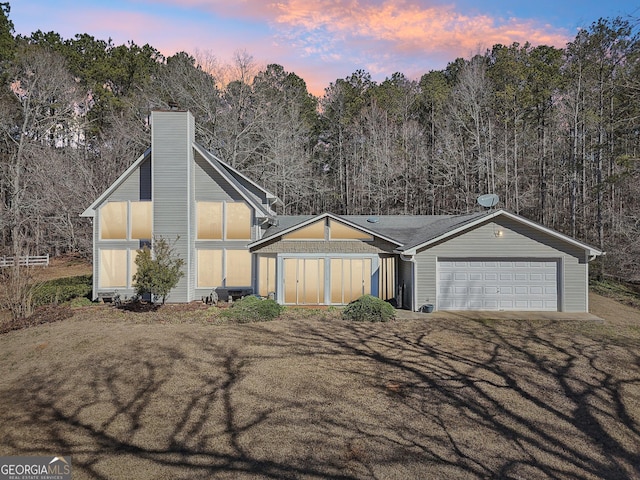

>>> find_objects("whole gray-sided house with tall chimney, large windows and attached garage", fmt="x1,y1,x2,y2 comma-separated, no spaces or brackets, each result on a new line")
82,111,602,311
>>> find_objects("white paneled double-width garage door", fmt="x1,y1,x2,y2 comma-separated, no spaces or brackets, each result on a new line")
437,259,558,311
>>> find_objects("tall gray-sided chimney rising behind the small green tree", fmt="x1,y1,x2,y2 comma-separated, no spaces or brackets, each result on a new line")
151,111,195,302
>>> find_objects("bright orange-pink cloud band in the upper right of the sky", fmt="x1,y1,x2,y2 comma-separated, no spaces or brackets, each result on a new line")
273,0,568,58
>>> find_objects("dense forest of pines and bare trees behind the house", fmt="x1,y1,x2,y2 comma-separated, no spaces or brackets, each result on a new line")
0,2,640,281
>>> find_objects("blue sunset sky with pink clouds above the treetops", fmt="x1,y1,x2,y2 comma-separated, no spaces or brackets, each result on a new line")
9,0,640,95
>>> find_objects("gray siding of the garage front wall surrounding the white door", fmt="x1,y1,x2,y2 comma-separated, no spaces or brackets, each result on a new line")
415,218,588,312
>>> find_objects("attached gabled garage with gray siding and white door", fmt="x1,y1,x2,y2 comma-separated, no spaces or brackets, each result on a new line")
400,210,602,312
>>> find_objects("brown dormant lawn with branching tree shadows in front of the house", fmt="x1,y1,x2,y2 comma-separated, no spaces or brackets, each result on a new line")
0,296,640,480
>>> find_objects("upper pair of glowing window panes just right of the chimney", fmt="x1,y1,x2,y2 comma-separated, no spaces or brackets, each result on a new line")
197,202,252,240
